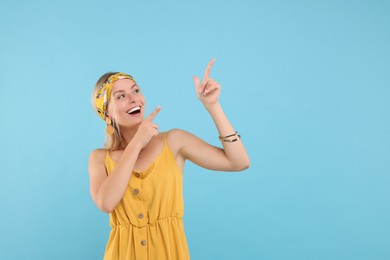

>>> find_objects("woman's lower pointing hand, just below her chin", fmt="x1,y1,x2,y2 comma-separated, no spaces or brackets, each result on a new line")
133,106,161,149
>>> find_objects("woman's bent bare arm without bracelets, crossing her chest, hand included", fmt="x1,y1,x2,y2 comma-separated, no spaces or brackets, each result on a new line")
89,108,160,213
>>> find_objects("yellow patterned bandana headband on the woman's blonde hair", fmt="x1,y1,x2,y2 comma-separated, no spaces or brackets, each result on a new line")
96,72,134,120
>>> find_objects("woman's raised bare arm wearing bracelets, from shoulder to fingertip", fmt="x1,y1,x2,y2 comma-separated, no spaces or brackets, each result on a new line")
176,59,250,171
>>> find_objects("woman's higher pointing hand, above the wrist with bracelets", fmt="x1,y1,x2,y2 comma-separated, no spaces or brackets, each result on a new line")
193,59,221,105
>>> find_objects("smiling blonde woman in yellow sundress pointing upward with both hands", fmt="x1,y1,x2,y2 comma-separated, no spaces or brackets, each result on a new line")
89,59,249,260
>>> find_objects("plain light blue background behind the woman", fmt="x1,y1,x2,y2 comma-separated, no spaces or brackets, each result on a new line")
0,0,390,260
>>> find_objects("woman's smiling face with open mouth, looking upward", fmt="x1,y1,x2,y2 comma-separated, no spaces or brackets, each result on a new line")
108,79,145,128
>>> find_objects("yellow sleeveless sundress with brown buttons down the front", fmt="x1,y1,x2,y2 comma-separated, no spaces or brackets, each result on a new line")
104,133,190,260
